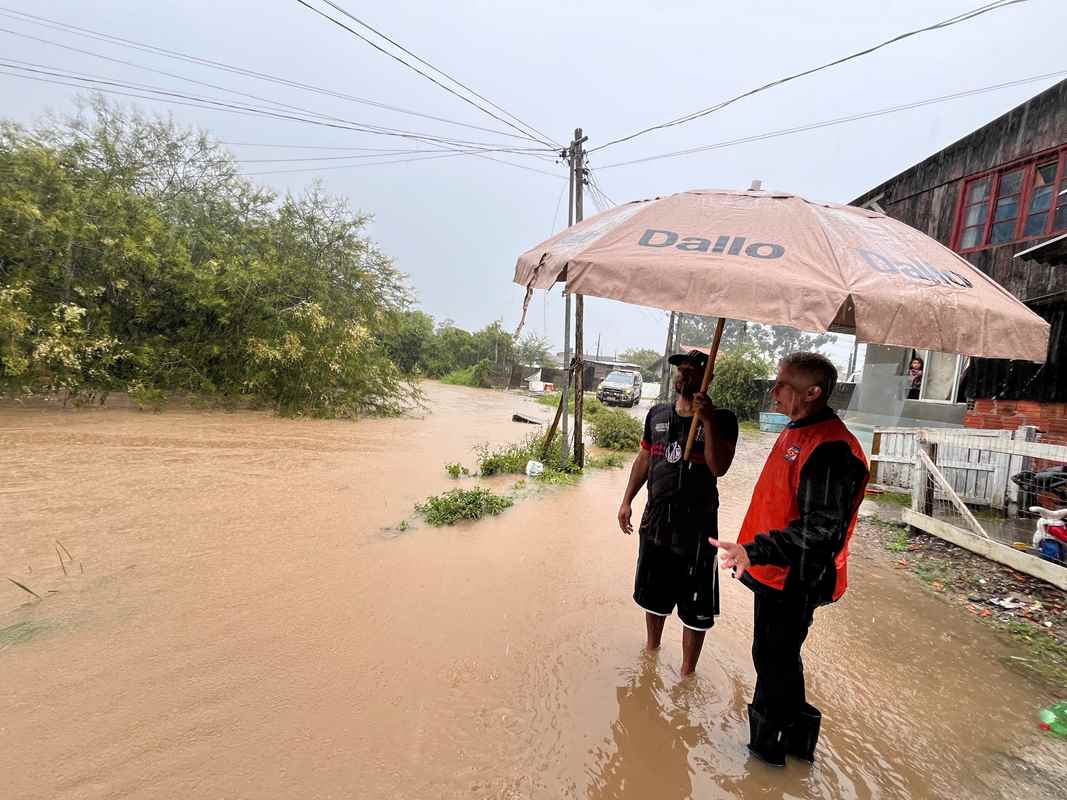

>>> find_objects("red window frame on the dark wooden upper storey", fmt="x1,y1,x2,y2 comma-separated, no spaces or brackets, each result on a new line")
952,145,1067,253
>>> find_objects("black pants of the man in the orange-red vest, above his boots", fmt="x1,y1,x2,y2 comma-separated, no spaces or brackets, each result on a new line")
752,590,814,726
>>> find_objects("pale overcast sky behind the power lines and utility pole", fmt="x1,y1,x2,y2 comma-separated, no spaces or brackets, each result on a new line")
0,0,1067,369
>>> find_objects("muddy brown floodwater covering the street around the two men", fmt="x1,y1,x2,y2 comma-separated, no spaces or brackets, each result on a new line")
0,384,1064,800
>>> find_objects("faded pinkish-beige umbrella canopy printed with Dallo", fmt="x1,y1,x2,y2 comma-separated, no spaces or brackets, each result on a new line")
514,189,1049,362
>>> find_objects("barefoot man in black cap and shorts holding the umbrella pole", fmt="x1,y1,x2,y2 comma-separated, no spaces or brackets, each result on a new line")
618,350,737,677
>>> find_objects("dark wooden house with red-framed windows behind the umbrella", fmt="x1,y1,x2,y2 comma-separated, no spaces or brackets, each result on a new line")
851,80,1067,433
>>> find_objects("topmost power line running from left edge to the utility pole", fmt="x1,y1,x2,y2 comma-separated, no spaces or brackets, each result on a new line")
0,6,537,144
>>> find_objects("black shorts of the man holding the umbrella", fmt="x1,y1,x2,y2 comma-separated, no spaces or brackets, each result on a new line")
634,537,719,630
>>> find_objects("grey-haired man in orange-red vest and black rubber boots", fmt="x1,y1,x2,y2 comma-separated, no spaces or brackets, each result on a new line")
711,353,867,766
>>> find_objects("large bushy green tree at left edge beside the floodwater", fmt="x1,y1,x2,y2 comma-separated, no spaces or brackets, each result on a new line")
0,99,411,416
